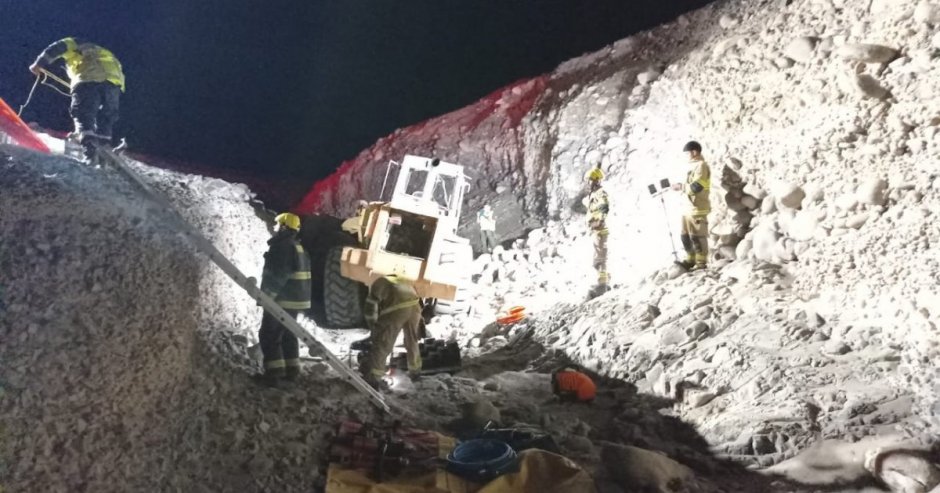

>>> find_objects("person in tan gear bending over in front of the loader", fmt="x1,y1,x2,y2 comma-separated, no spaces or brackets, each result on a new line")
360,275,421,389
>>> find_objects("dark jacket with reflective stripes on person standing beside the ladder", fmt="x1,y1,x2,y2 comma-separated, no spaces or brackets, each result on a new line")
261,230,312,310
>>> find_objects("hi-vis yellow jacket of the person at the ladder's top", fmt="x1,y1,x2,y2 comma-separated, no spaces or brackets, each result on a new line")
39,38,124,92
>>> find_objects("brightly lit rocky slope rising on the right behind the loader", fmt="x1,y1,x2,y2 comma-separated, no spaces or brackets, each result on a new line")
298,0,940,484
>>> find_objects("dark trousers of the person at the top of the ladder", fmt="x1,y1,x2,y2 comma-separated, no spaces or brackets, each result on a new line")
69,82,121,144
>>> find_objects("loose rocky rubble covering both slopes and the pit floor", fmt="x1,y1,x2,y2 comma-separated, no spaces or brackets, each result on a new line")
0,0,940,492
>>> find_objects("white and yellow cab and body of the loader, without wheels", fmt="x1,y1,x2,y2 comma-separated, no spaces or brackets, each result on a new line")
341,155,472,300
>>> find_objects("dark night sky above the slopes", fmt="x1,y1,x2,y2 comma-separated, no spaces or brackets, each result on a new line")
0,0,709,183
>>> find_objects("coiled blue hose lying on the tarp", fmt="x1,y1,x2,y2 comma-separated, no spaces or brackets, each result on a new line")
447,438,518,483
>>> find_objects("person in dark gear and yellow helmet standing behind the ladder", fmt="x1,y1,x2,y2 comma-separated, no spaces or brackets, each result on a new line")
258,213,311,386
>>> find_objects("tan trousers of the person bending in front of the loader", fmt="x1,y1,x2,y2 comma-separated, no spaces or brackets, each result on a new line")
360,306,421,377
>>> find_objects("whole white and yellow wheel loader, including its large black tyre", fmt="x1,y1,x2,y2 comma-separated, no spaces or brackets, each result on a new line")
301,155,473,328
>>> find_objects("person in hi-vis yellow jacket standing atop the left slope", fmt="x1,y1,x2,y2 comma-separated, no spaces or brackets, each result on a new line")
29,38,124,158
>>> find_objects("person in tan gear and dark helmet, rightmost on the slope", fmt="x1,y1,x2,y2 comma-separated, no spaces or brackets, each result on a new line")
672,140,711,270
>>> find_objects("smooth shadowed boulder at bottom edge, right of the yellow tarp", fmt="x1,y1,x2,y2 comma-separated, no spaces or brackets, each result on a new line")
601,443,696,493
